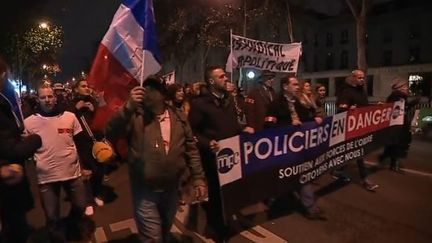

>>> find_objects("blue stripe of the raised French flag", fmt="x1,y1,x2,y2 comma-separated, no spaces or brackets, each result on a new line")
123,0,161,63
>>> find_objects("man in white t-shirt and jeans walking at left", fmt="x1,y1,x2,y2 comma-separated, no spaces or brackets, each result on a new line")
24,85,91,242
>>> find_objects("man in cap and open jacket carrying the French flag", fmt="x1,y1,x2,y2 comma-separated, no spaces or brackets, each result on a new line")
106,77,207,242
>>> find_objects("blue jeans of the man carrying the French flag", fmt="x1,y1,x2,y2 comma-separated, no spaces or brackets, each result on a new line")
131,185,178,242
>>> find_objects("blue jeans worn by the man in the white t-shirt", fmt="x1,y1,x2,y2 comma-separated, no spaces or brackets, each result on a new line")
39,177,87,238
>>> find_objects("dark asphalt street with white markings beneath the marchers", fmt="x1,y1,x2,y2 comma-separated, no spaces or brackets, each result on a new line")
25,139,432,243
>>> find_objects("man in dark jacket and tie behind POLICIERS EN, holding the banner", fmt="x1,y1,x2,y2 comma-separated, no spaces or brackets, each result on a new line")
265,76,325,220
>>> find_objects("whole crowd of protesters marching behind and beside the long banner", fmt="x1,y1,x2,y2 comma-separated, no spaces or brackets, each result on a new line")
0,52,420,242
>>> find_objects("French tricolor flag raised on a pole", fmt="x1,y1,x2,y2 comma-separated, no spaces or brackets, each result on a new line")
88,0,161,129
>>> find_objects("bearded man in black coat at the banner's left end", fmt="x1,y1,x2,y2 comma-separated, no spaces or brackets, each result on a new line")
189,66,250,241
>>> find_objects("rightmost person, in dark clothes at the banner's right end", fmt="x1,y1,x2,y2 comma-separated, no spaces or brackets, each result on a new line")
379,78,419,173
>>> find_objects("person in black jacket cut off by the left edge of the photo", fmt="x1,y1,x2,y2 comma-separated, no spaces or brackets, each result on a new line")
0,58,42,243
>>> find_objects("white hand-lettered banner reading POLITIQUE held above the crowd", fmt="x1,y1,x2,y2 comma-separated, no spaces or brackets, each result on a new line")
226,35,301,73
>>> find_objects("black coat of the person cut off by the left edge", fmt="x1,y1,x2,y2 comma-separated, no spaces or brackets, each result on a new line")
0,92,42,210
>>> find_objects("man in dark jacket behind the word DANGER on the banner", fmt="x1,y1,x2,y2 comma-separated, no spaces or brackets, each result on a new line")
332,70,378,191
